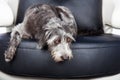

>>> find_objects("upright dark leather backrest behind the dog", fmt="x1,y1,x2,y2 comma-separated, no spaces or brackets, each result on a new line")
16,0,103,35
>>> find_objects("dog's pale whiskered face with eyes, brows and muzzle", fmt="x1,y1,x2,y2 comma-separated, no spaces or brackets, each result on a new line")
47,28,75,62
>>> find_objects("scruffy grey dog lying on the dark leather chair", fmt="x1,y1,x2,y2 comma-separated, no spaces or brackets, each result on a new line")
5,4,77,62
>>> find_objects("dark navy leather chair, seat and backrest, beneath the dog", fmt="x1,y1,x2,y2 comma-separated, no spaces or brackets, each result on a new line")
0,0,120,78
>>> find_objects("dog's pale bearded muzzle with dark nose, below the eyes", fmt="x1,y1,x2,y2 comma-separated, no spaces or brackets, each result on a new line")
49,43,73,62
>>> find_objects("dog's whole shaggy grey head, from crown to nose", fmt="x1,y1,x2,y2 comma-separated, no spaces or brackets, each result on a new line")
44,15,77,62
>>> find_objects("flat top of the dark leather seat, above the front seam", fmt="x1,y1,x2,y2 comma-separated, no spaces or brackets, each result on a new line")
0,33,120,49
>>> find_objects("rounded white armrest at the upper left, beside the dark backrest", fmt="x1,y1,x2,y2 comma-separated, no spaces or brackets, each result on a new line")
0,0,14,26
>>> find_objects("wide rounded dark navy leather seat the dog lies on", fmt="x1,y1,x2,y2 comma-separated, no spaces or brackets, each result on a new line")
0,33,120,78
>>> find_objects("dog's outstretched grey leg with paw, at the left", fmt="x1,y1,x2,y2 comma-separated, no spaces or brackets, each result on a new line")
5,23,23,62
